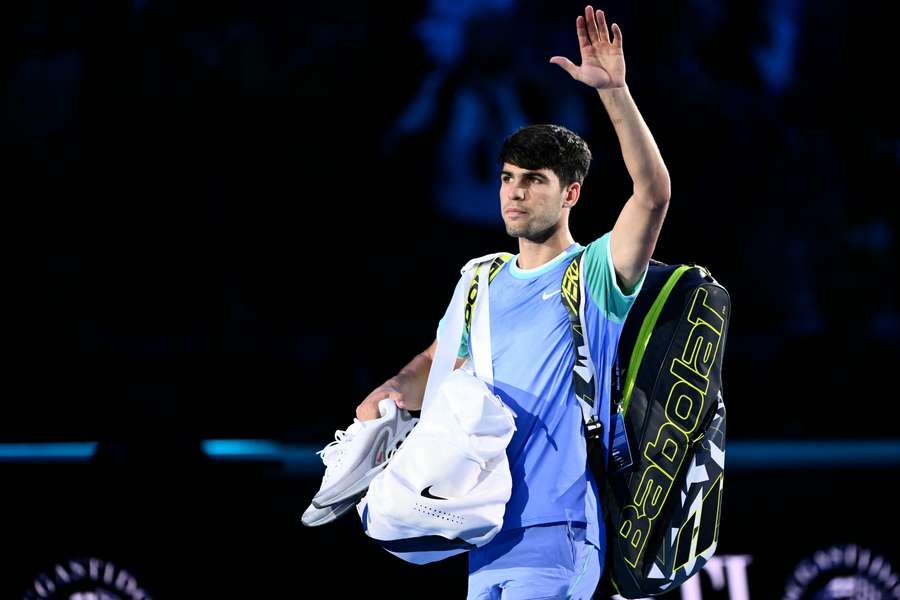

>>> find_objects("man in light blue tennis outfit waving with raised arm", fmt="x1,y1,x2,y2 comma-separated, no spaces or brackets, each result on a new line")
356,6,670,600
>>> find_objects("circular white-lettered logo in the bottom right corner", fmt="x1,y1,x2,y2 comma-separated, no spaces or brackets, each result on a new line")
782,544,900,600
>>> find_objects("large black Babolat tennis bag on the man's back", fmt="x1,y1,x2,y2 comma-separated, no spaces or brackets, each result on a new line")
598,261,731,598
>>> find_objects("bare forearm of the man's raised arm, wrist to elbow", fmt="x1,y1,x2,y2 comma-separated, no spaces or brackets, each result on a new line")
597,86,670,205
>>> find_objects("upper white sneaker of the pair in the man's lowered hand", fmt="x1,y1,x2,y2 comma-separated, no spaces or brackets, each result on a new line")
312,398,419,508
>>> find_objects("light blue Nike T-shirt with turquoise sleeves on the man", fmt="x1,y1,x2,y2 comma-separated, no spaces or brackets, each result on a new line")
445,233,646,547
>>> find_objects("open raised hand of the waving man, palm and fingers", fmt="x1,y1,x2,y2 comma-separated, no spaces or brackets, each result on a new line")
550,6,625,90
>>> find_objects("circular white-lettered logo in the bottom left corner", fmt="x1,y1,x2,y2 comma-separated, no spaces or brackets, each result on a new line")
24,558,153,600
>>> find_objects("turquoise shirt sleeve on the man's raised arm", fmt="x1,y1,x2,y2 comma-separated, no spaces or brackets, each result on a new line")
582,232,647,323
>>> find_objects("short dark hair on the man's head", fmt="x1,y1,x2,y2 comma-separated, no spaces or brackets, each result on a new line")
500,125,591,187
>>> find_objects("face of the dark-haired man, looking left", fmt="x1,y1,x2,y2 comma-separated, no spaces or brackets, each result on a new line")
500,163,578,243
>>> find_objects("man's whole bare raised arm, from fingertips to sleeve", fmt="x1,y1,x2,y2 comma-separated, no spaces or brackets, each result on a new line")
550,6,671,293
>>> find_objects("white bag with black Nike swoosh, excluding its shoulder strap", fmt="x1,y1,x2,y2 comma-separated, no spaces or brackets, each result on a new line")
357,369,515,564
